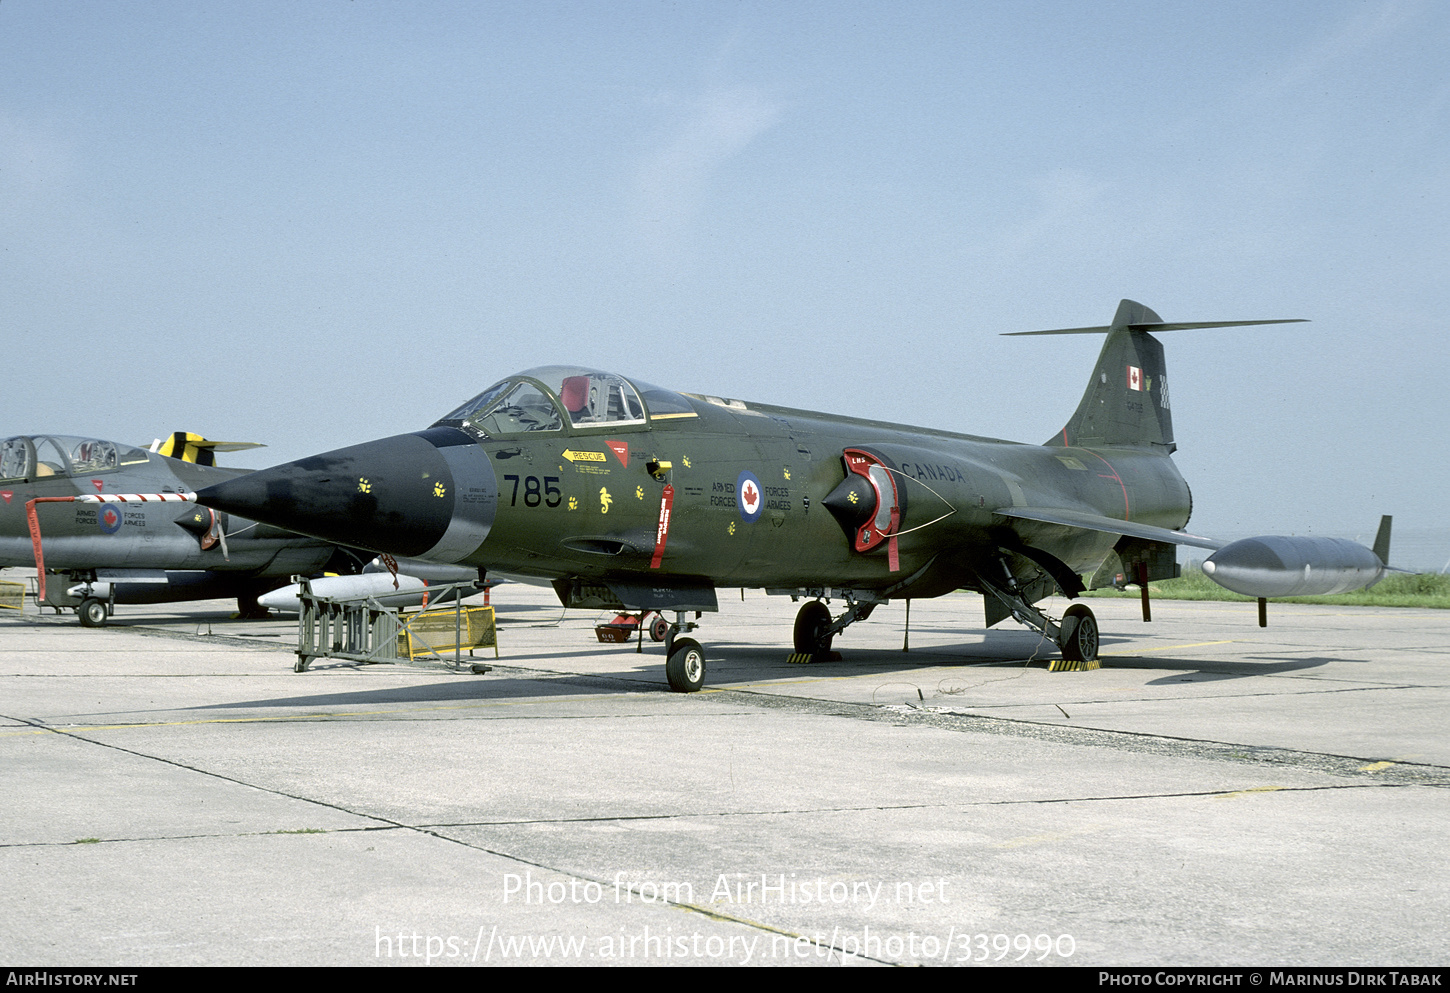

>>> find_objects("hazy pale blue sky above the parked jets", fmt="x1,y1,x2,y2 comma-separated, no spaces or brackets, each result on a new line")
0,0,1450,568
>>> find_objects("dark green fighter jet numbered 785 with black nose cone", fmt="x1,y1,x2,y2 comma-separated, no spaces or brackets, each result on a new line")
197,300,1383,691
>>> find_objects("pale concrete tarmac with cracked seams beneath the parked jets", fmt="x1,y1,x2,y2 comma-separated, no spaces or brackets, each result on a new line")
0,584,1450,967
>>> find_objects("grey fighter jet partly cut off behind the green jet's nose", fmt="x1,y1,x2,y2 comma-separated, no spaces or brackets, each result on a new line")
0,432,363,628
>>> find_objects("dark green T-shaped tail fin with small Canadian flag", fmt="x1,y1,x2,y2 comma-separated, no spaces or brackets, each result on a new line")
1014,300,1298,452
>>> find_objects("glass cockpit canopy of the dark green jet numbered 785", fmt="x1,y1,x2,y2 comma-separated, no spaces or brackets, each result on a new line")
435,365,693,436
